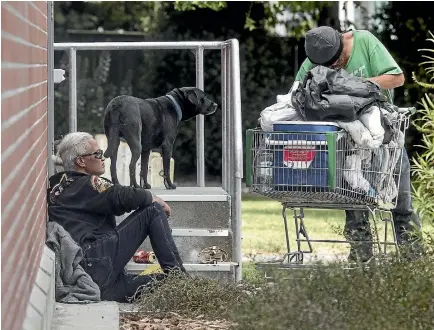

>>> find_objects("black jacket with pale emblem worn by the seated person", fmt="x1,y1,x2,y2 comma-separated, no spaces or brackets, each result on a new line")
47,172,152,246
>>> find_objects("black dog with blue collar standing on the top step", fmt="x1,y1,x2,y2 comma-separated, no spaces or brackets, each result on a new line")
104,87,217,189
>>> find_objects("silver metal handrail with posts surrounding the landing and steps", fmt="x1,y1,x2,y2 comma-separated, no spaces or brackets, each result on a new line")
49,39,243,280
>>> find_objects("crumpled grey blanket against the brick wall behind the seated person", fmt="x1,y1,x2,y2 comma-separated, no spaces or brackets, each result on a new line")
46,221,101,303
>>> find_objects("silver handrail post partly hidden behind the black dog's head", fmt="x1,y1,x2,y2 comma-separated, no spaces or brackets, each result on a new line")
195,46,205,187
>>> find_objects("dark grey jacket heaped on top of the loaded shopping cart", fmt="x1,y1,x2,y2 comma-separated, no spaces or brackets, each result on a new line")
292,66,394,122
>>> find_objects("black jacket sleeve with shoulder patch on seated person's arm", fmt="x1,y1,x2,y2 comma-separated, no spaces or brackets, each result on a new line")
85,177,152,215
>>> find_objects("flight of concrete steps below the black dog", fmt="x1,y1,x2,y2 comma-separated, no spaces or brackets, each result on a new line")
117,187,237,280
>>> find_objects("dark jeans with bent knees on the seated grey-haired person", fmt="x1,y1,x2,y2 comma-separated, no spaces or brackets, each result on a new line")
82,203,185,302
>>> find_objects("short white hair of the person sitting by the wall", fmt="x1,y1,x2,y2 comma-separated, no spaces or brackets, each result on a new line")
52,132,93,172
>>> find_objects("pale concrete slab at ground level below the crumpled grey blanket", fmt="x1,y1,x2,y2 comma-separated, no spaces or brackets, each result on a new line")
51,301,119,330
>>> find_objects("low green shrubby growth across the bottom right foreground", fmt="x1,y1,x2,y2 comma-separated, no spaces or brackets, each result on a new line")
130,255,434,330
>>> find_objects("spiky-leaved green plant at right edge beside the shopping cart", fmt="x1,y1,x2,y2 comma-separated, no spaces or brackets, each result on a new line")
413,32,434,221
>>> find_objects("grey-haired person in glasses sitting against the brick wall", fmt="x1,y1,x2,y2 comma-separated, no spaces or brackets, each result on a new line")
48,132,185,302
